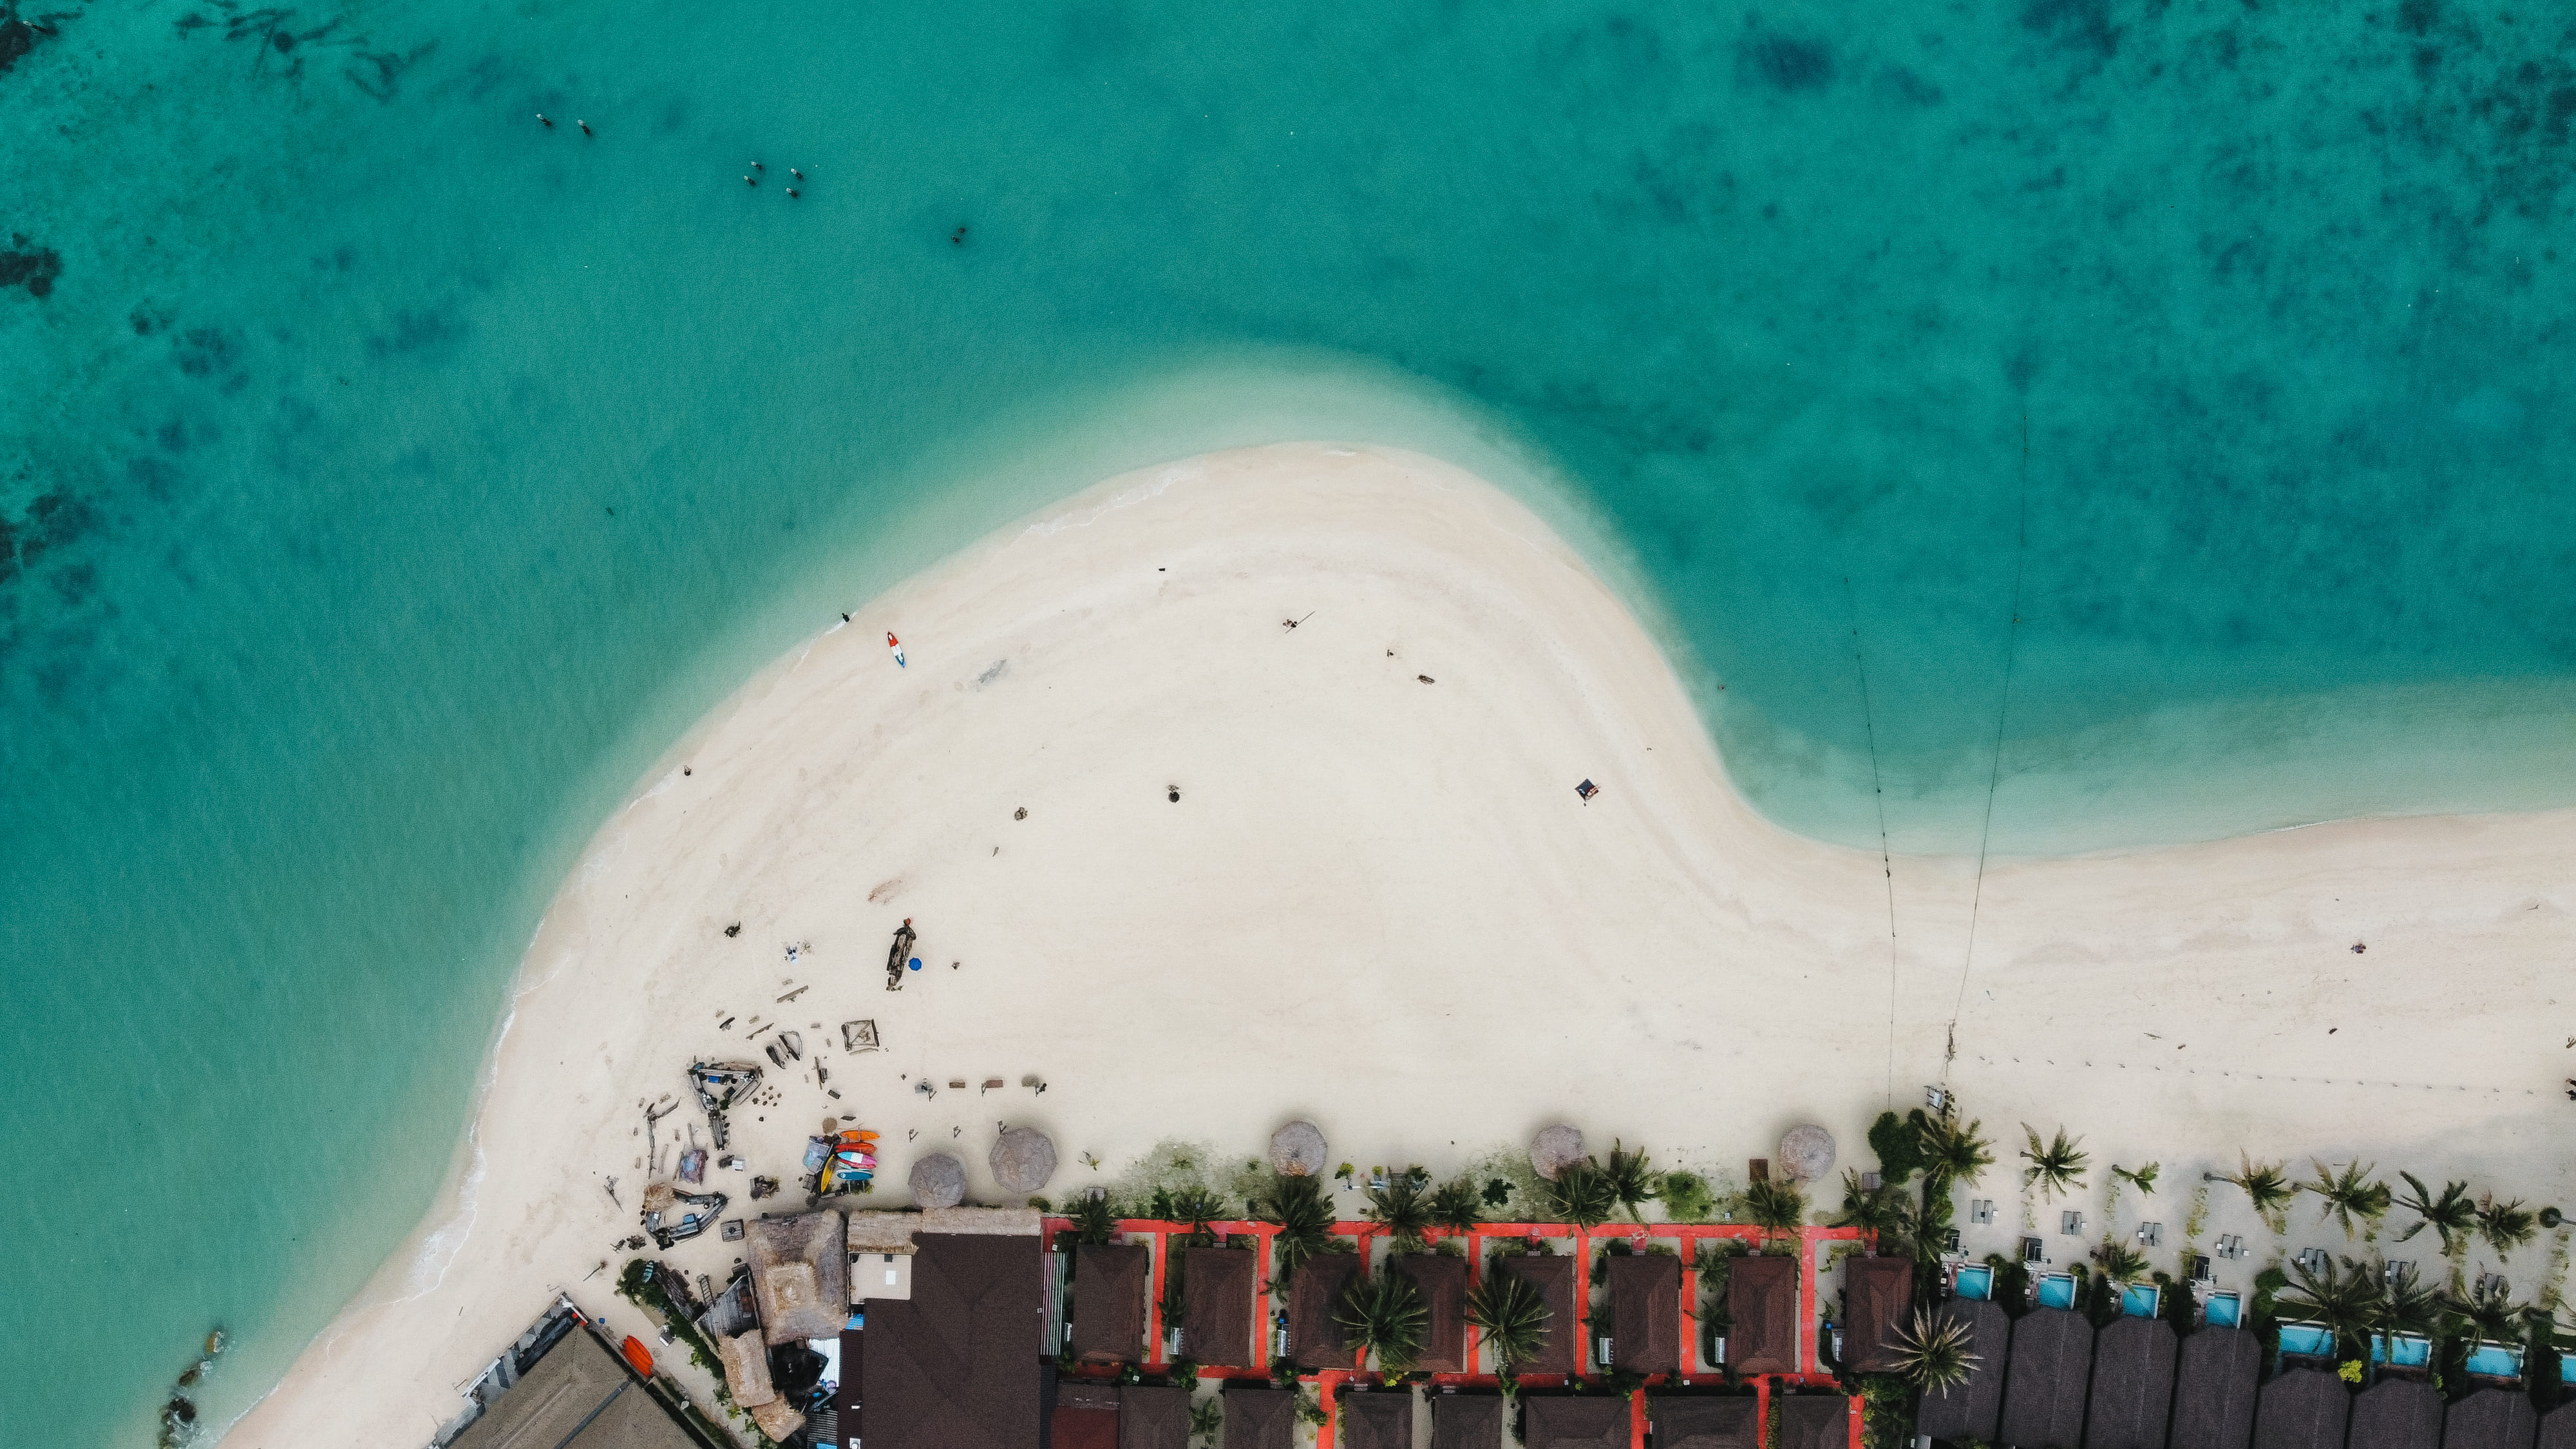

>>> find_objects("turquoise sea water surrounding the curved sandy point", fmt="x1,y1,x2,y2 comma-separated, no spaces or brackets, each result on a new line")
0,0,2576,1446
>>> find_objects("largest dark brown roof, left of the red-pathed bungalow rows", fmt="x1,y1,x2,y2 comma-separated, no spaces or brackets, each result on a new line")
842,1233,1046,1449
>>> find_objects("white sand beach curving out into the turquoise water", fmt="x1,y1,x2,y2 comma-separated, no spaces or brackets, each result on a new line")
227,444,2576,1449
